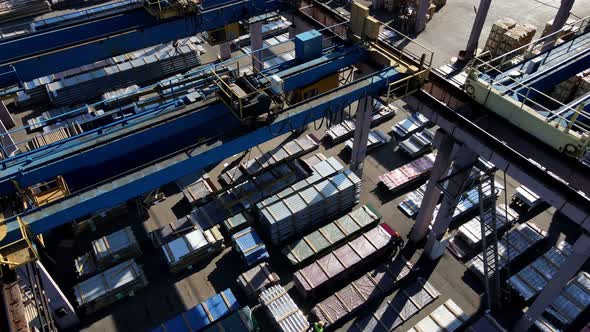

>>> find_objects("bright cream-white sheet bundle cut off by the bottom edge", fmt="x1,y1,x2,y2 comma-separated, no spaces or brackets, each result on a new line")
408,299,469,332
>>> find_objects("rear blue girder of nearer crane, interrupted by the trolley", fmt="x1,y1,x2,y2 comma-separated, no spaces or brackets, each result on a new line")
0,46,368,193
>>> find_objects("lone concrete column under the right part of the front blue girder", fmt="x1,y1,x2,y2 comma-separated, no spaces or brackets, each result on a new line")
350,96,373,179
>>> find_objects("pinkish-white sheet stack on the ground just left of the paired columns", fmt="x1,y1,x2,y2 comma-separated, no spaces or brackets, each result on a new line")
379,153,436,191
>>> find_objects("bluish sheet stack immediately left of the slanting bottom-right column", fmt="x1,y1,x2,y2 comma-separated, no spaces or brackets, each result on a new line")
508,241,573,301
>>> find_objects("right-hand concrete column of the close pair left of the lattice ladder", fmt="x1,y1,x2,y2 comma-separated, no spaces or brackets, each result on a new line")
424,147,477,259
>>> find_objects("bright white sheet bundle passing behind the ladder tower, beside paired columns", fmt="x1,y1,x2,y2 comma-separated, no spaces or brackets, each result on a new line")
457,205,518,248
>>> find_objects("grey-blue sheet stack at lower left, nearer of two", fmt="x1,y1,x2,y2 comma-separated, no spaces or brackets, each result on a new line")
74,260,148,313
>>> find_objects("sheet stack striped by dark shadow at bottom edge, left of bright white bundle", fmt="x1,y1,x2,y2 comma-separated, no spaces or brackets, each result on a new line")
349,278,440,332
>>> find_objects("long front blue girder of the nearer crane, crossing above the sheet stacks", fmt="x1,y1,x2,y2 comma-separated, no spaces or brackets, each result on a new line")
0,68,404,245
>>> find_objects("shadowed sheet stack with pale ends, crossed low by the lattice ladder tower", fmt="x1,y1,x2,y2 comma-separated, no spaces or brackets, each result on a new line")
465,222,546,279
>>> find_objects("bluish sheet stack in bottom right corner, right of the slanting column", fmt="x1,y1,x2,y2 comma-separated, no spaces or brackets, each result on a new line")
535,271,590,332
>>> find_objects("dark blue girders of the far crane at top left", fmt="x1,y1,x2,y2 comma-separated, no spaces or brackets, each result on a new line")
0,0,290,86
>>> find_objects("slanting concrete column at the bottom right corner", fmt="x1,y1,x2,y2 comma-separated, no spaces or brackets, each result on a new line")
512,234,590,332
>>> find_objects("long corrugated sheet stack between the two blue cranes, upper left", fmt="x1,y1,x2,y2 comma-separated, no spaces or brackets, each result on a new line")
46,42,200,105
